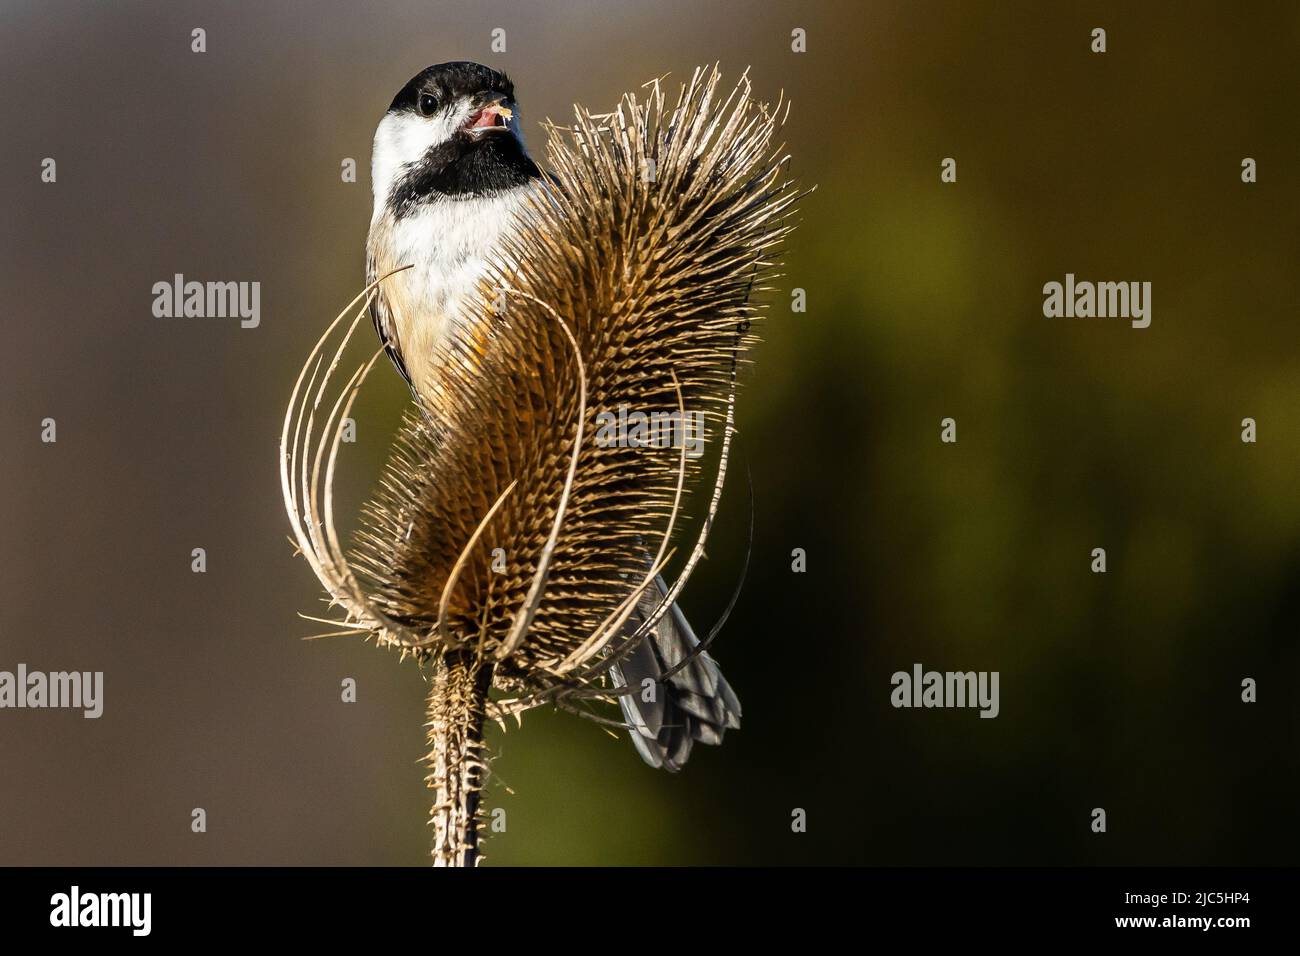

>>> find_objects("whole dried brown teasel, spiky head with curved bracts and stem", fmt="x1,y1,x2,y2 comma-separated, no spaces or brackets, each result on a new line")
281,68,800,865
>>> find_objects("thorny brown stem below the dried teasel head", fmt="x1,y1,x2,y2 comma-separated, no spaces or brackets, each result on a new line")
425,654,493,866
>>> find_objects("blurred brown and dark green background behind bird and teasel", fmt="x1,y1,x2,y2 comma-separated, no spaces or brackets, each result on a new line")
0,0,1300,865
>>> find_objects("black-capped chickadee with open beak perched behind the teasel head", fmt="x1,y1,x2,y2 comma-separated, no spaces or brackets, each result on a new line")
365,61,741,771
